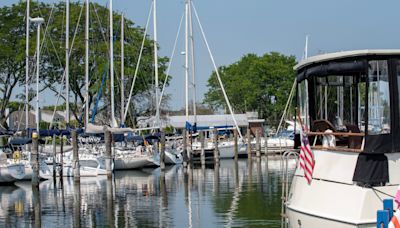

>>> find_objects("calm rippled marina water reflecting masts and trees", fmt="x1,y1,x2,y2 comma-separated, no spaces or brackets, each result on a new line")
0,157,296,227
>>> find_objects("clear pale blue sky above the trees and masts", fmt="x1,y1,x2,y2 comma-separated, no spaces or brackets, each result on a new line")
0,0,400,109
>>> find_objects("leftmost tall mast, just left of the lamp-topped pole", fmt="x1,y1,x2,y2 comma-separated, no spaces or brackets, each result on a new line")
25,0,30,129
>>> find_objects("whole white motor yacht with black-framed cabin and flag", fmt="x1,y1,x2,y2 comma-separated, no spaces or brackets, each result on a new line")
285,50,400,227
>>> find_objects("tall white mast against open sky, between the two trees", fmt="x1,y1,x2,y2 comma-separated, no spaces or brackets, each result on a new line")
185,0,189,121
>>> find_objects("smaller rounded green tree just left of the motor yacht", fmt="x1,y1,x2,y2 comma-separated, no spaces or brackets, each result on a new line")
204,52,296,125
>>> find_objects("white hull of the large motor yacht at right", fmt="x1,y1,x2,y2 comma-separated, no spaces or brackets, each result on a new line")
286,150,400,227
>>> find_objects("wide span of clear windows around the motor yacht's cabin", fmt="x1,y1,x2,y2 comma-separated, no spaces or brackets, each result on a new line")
297,60,394,149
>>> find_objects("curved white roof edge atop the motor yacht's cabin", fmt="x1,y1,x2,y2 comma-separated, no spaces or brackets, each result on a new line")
293,49,400,70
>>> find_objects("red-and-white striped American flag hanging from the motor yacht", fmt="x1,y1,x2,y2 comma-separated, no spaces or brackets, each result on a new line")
300,127,314,184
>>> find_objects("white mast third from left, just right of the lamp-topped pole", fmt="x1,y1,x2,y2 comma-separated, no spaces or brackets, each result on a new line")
65,0,70,127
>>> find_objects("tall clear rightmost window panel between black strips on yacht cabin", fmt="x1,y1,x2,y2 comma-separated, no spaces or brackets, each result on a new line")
368,60,390,135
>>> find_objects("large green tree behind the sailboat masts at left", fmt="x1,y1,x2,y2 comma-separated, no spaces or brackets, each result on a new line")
0,1,168,129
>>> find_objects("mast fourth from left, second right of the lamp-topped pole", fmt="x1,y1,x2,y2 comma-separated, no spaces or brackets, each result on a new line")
85,0,89,129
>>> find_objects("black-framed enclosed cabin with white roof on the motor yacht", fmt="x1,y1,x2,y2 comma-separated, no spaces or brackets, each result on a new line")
295,50,400,183
